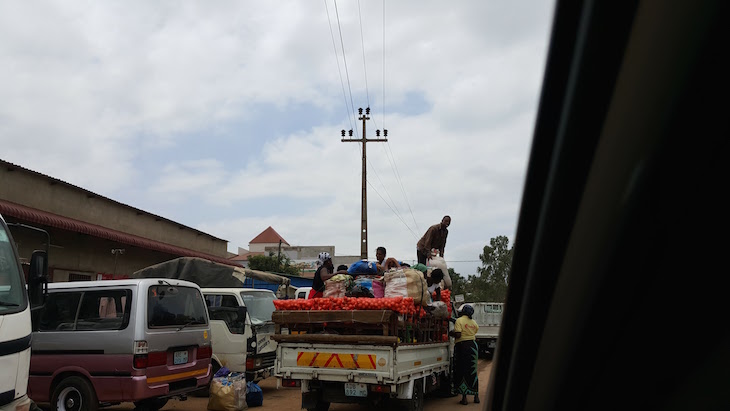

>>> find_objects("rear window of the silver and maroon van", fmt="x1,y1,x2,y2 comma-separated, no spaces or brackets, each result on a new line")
147,285,208,328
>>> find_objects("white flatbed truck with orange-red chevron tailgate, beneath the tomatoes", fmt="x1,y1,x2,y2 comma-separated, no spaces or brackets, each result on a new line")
273,310,453,411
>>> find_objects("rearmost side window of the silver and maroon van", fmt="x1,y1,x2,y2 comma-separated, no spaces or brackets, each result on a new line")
76,290,132,330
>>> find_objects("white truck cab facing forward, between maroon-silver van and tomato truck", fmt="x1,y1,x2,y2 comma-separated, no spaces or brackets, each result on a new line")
202,288,276,381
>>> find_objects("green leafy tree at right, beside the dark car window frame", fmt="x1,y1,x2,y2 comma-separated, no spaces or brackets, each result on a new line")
468,236,514,302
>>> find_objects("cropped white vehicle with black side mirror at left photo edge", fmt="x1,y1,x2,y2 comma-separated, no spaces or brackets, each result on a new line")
0,216,50,411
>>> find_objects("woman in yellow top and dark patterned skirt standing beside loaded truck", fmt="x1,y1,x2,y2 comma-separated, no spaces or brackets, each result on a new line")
449,304,479,405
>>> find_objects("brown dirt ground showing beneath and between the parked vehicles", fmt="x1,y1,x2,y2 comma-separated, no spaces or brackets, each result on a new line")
99,359,492,411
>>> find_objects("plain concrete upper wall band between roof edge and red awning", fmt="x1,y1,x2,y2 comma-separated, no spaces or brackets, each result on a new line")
0,166,228,258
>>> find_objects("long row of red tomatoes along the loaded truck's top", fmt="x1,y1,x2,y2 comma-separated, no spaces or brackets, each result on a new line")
274,297,417,314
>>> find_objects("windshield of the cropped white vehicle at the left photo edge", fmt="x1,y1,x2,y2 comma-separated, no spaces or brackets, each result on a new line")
0,223,27,315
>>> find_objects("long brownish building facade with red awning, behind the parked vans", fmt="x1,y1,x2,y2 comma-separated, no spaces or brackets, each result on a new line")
0,160,232,282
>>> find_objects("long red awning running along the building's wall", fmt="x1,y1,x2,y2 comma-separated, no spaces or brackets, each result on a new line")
0,200,239,267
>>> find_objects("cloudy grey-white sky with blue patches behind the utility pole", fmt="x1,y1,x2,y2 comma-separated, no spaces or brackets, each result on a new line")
0,0,553,275
